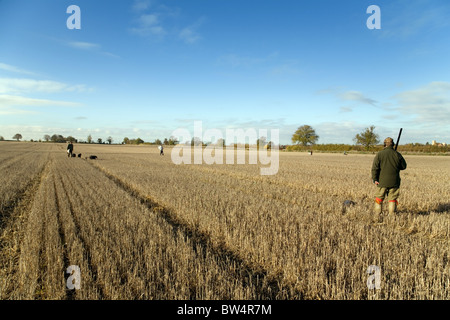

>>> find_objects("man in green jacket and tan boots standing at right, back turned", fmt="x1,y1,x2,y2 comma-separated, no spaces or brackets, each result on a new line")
372,138,406,214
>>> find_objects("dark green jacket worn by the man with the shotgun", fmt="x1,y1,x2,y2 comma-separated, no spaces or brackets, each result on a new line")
372,146,406,188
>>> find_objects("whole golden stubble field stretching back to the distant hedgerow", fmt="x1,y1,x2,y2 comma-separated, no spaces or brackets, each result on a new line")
0,142,450,300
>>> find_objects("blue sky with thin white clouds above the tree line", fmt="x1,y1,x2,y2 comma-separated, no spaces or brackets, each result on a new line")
0,0,450,143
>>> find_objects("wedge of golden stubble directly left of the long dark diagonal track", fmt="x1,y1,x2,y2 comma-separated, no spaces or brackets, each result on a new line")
36,151,270,299
